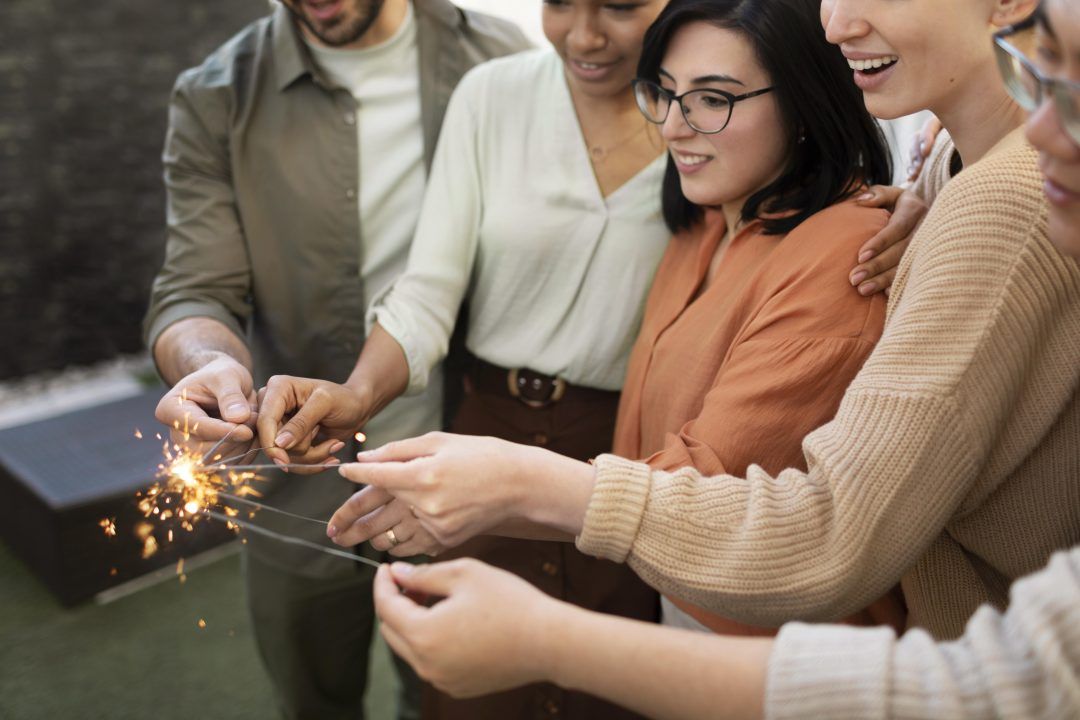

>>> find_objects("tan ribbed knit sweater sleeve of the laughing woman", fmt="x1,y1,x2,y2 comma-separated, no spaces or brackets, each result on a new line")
578,133,1080,635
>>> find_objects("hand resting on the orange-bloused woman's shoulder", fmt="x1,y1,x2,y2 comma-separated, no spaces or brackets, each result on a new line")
849,185,929,296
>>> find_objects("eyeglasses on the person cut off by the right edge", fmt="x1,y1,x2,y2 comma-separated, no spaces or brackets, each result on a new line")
994,17,1080,144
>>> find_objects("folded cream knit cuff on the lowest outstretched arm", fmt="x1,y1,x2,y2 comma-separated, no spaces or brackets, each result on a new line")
765,623,896,720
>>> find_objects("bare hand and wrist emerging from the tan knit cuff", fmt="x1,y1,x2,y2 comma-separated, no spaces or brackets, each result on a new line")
329,433,593,547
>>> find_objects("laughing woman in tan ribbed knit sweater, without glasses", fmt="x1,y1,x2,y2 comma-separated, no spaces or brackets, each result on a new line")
334,0,1080,660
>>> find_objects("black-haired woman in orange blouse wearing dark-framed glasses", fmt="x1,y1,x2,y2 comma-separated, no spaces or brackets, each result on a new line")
324,0,903,634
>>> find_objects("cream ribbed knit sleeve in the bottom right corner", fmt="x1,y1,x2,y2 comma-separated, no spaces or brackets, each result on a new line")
766,548,1080,720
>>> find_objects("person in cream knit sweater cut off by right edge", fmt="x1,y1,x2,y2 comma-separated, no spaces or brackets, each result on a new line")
332,0,1080,718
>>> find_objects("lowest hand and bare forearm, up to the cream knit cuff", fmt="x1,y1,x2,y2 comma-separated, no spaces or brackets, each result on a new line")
375,559,773,720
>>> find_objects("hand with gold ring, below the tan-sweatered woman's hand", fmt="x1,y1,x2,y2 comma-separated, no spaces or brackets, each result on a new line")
326,487,446,557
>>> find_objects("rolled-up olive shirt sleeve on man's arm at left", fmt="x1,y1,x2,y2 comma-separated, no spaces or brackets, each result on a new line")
144,68,252,349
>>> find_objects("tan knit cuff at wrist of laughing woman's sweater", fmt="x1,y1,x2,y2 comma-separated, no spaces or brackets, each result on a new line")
577,454,652,562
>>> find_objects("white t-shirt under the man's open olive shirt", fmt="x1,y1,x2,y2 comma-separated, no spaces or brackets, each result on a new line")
308,3,443,448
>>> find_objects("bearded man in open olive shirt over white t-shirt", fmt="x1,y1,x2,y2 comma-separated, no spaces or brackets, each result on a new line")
145,0,527,720
